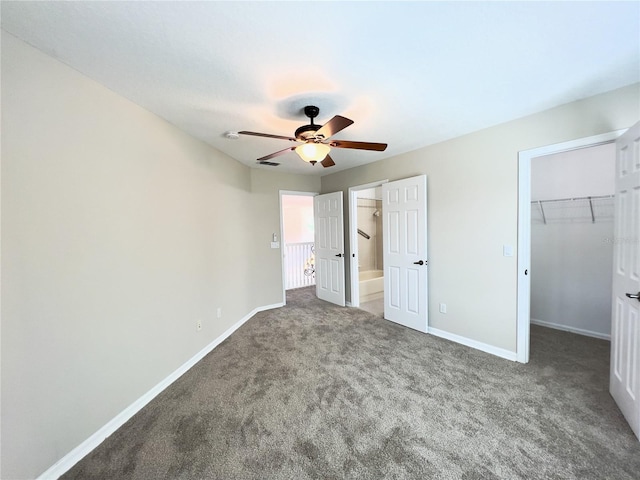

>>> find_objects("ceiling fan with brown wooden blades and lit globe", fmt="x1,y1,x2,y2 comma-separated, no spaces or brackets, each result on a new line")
238,105,387,168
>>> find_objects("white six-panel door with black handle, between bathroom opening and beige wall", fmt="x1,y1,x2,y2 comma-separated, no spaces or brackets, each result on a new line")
382,175,428,333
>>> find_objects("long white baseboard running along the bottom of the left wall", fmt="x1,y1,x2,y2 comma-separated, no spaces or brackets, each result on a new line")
38,302,284,480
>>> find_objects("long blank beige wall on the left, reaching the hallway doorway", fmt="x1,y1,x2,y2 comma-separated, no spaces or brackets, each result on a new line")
0,33,320,479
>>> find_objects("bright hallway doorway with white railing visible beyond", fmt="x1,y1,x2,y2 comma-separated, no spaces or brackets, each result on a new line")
282,191,317,304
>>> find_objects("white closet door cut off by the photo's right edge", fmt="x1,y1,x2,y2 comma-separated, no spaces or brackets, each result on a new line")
609,123,640,438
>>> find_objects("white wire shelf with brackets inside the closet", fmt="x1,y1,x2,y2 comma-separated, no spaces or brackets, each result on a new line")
531,195,615,225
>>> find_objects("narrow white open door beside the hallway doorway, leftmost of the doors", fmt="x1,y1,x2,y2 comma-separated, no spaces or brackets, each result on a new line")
313,192,344,307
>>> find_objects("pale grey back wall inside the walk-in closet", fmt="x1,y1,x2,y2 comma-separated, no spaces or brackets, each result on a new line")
531,144,615,338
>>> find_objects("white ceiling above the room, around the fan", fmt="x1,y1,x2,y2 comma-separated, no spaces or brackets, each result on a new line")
2,1,640,175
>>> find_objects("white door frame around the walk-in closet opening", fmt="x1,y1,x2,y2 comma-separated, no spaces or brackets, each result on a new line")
516,130,625,363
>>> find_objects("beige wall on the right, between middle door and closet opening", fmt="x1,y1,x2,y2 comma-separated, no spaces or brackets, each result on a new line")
322,84,640,352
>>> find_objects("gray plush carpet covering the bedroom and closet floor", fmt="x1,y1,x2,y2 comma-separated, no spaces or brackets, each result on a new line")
62,288,640,480
